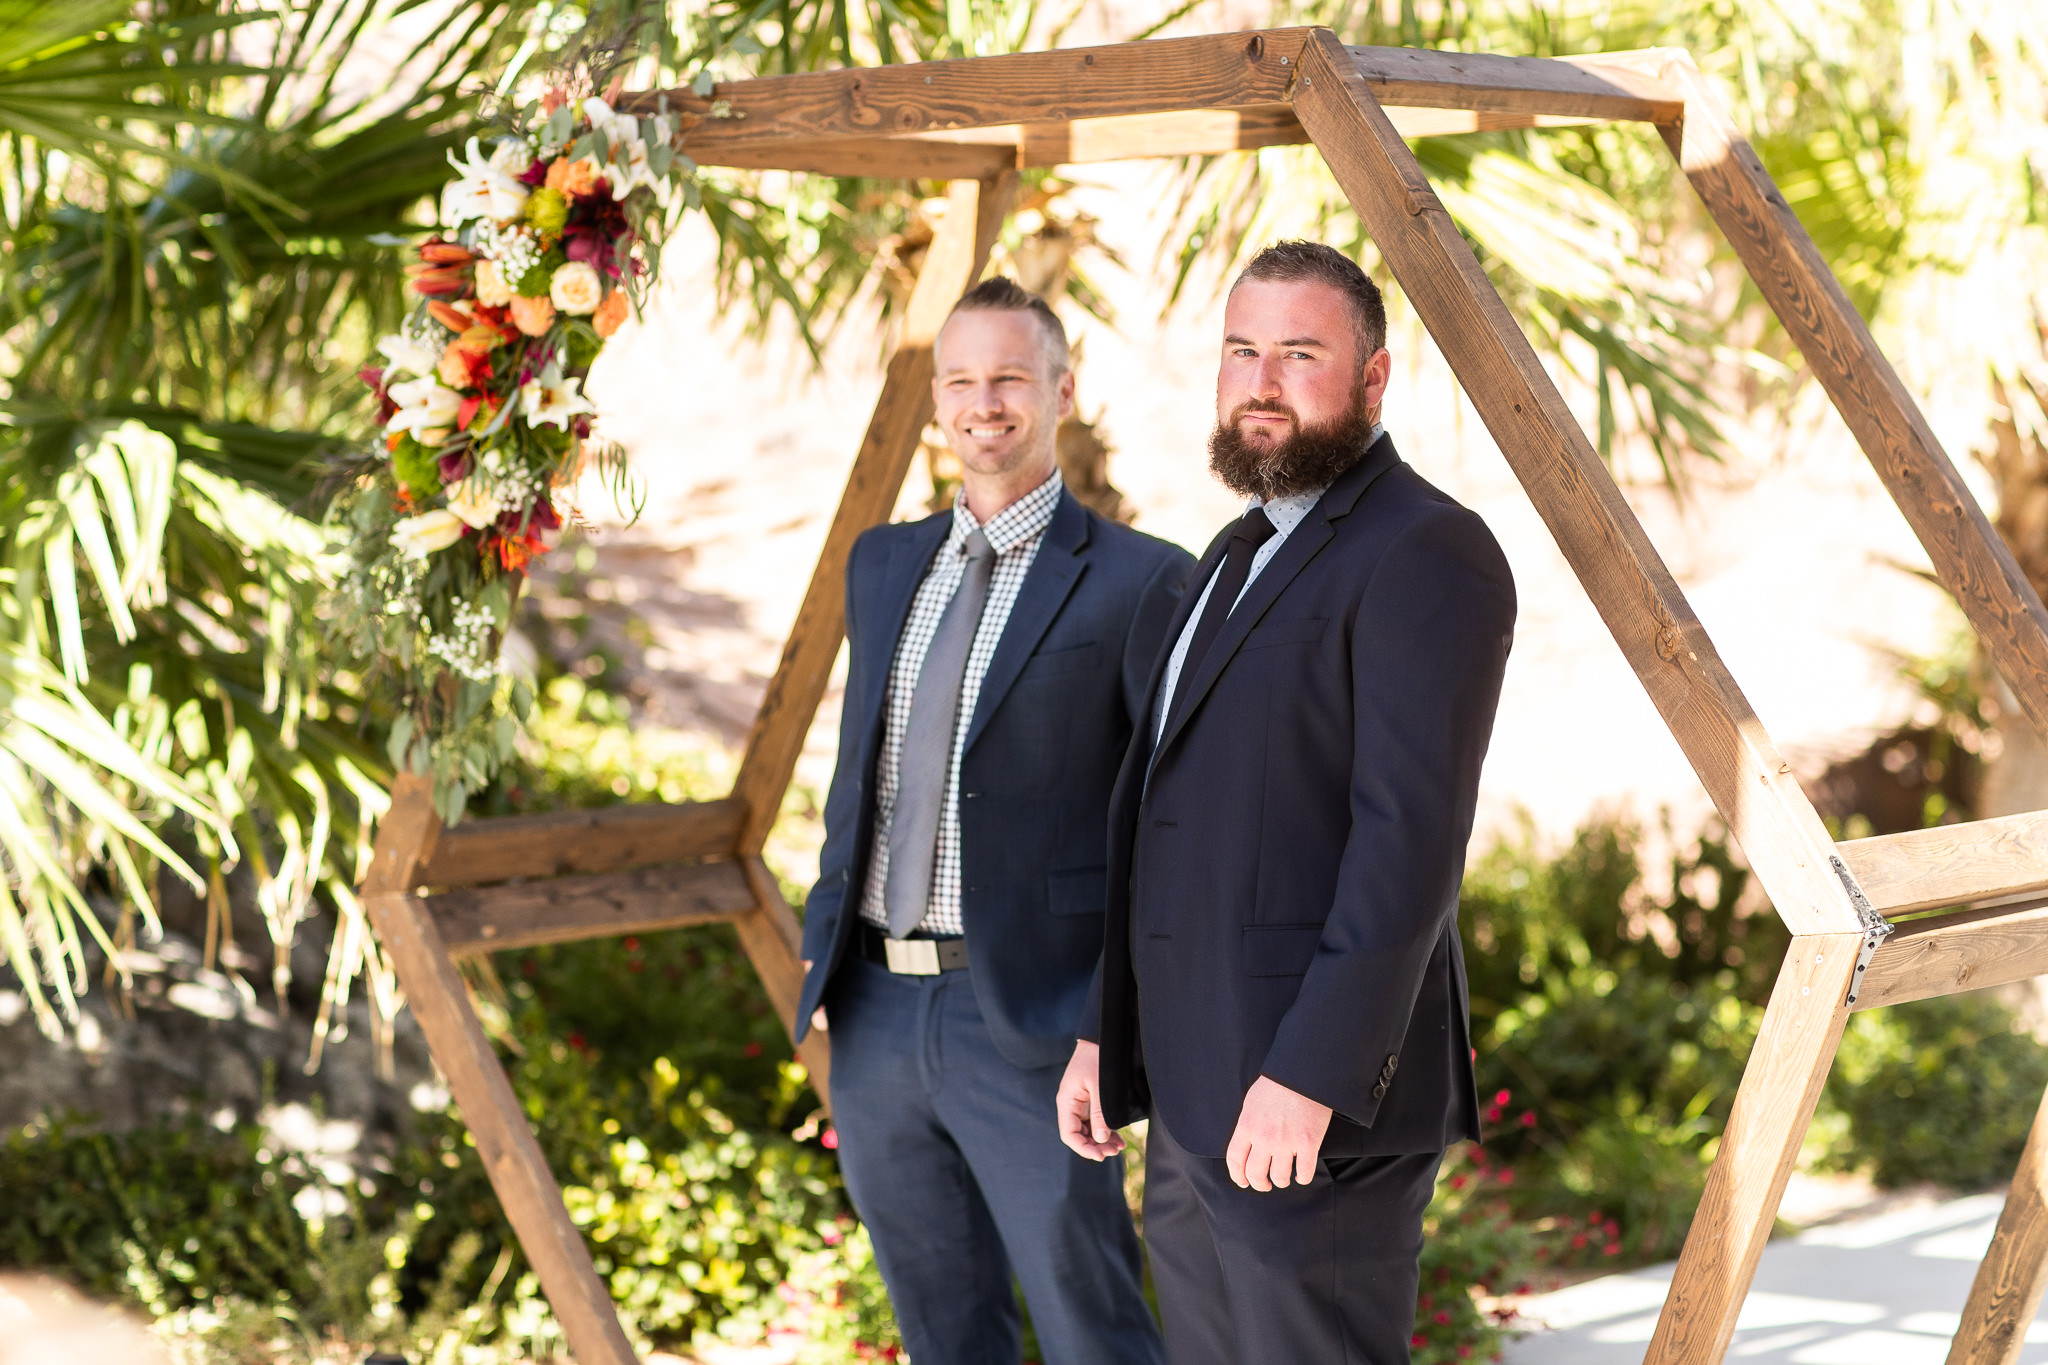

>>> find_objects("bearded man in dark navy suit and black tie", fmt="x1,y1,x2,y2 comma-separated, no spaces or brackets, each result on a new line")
1059,241,1516,1365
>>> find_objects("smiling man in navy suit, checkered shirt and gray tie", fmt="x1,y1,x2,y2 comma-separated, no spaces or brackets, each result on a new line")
799,278,1194,1365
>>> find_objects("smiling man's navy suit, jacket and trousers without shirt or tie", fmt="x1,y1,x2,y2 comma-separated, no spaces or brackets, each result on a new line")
797,491,1194,1365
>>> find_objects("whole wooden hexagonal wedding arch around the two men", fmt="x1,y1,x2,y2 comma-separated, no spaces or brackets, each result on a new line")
362,29,2048,1365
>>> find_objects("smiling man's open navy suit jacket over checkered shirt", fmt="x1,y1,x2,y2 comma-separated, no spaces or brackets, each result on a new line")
797,491,1194,1064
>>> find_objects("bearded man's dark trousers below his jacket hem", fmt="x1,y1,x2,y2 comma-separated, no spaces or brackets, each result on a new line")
1138,1115,1444,1365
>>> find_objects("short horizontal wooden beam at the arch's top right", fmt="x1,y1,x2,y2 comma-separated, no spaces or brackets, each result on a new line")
1346,47,1686,127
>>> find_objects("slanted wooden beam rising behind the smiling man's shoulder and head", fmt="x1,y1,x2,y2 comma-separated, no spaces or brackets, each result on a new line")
733,170,1016,855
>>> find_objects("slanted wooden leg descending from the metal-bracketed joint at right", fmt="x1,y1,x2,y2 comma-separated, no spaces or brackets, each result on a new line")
1642,933,1864,1365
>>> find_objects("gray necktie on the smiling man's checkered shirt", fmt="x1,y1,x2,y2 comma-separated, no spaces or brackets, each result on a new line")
883,530,995,939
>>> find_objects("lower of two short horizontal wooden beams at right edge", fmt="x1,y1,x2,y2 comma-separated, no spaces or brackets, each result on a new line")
1855,900,2048,1009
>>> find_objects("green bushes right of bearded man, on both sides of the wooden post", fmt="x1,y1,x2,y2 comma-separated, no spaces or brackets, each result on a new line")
1462,823,2048,1265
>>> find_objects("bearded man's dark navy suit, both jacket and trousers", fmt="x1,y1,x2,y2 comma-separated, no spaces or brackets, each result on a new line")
1083,436,1516,1365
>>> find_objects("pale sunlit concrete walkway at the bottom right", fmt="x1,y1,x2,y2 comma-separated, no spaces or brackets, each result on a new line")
1501,1193,2048,1365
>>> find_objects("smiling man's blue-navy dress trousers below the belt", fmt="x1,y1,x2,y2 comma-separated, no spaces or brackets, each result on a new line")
825,958,1163,1365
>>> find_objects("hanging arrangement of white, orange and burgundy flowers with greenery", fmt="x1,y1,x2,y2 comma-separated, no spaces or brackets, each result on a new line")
336,84,694,823
